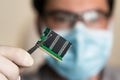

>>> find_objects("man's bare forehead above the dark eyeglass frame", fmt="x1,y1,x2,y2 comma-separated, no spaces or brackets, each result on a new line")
47,0,108,13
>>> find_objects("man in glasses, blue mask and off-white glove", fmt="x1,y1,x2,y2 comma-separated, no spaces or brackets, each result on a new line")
0,0,114,80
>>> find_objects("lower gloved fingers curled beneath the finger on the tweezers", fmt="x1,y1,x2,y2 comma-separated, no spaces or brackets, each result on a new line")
0,56,19,80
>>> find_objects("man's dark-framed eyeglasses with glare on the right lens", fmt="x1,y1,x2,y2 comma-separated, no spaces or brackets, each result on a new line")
44,10,109,29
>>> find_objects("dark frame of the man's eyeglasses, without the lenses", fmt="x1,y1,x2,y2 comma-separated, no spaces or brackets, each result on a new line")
42,10,110,26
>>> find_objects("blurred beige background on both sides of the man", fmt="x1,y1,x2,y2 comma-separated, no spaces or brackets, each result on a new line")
0,0,120,79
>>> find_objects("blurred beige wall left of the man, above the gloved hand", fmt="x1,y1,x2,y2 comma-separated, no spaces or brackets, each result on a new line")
0,0,34,47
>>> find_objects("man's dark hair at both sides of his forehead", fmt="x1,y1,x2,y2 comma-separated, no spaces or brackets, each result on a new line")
33,0,115,15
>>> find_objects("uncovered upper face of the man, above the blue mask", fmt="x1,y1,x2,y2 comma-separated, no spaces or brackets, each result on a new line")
42,0,109,29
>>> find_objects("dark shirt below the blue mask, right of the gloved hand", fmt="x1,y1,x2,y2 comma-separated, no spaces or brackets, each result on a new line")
21,64,67,80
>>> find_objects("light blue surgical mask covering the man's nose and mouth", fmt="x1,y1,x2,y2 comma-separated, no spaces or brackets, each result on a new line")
47,23,113,80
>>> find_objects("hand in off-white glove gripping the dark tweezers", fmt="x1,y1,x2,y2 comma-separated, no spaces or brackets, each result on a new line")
0,46,34,80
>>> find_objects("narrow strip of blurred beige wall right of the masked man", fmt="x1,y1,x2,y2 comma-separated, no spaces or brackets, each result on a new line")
109,0,120,67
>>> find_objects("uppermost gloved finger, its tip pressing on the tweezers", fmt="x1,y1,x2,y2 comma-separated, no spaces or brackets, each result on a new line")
0,47,34,67
